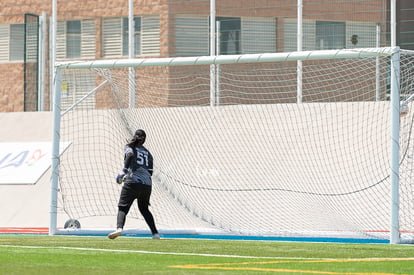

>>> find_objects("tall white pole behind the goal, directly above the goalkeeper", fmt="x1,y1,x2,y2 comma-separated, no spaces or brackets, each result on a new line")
128,0,136,108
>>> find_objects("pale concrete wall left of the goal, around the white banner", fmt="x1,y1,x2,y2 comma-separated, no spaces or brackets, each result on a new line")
0,112,61,227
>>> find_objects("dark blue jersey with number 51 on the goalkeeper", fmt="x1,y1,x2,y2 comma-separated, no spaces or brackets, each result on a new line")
124,145,153,185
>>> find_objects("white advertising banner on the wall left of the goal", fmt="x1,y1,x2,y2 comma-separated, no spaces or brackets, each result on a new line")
0,142,70,184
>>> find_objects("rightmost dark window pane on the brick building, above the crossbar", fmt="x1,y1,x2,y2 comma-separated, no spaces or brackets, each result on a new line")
315,21,346,50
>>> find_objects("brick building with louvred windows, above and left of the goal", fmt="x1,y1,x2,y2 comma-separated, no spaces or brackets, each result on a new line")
0,0,414,112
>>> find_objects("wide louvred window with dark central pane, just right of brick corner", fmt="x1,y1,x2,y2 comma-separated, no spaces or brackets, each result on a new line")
175,16,276,56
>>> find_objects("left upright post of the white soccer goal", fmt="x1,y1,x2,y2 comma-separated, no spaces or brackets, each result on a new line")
49,70,61,235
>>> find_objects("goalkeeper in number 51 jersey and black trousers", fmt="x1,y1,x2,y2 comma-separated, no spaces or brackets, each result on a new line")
108,129,160,239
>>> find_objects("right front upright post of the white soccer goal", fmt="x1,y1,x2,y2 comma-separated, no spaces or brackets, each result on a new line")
390,47,400,244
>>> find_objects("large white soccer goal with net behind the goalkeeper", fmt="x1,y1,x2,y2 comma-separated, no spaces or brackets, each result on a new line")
50,48,414,243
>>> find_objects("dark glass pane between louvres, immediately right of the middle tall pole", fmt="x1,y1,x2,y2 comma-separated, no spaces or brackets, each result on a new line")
216,17,241,55
